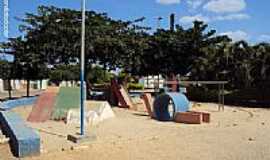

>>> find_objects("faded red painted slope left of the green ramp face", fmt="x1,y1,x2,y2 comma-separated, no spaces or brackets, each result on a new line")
27,87,58,123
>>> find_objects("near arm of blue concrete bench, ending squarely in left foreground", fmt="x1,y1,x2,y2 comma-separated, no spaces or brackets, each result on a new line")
0,111,40,157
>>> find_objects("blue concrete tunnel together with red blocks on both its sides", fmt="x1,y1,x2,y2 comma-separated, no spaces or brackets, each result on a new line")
141,92,210,124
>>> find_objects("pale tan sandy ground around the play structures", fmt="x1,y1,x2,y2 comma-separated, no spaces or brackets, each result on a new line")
0,104,270,160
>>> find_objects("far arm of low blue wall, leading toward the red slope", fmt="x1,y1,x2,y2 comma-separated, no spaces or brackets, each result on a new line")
0,97,37,110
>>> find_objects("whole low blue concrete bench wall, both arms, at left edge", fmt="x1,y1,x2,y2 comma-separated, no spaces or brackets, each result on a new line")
0,97,40,158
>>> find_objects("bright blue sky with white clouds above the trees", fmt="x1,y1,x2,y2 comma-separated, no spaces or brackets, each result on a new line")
0,0,270,43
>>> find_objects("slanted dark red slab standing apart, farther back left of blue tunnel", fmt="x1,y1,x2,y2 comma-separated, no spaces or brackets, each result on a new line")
111,80,134,108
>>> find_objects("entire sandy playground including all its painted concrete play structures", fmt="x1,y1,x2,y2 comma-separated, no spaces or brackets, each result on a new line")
0,79,270,160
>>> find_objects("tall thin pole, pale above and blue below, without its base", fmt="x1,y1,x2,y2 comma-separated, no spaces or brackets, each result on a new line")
80,0,86,136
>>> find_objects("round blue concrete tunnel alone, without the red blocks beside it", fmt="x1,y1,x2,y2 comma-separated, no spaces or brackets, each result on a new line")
154,92,189,121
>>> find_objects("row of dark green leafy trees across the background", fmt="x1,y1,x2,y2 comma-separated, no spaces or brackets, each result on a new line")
0,6,270,99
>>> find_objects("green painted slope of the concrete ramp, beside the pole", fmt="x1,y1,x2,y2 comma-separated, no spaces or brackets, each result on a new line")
52,87,80,119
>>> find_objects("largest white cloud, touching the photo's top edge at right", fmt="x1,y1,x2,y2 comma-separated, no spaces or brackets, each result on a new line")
203,0,246,13
